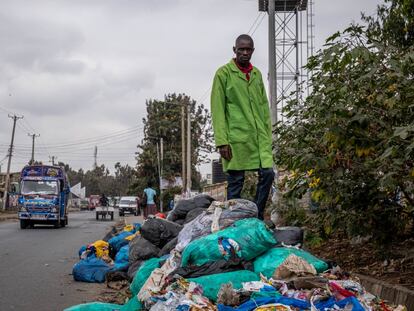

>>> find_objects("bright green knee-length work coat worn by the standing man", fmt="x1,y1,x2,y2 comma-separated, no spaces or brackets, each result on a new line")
211,60,273,171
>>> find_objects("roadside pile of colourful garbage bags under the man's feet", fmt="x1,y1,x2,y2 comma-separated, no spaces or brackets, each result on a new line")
66,195,406,311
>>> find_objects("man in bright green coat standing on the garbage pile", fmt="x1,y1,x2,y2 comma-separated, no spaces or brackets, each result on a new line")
211,35,275,220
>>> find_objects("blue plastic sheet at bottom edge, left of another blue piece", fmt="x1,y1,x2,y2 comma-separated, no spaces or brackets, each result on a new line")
218,297,311,311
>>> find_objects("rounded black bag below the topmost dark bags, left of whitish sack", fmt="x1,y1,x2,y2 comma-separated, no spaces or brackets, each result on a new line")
141,218,183,248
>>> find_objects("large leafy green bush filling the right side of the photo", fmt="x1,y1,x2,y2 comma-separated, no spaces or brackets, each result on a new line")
276,0,414,243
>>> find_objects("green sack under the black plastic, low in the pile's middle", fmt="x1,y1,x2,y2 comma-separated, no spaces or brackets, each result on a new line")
188,270,260,302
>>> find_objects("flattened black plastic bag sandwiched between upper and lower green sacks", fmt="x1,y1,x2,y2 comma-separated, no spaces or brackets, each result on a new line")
169,258,253,279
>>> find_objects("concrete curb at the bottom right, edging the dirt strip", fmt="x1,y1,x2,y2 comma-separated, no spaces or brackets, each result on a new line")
355,274,414,310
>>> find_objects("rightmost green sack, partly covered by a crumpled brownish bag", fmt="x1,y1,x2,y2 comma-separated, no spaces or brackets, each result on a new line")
253,247,328,278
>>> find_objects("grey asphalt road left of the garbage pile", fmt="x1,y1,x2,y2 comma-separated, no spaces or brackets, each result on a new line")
0,211,121,311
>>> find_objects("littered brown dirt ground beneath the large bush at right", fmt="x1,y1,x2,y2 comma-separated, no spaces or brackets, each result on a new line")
309,238,414,290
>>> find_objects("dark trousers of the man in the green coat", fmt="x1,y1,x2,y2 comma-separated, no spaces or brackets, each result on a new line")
227,168,275,220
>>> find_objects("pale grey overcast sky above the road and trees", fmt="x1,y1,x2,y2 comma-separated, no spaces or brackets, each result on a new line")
0,0,381,173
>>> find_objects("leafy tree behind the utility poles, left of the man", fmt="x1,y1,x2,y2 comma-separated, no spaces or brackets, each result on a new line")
134,94,212,207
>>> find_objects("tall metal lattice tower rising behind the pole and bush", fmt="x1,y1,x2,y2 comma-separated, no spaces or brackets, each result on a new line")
259,0,315,121
